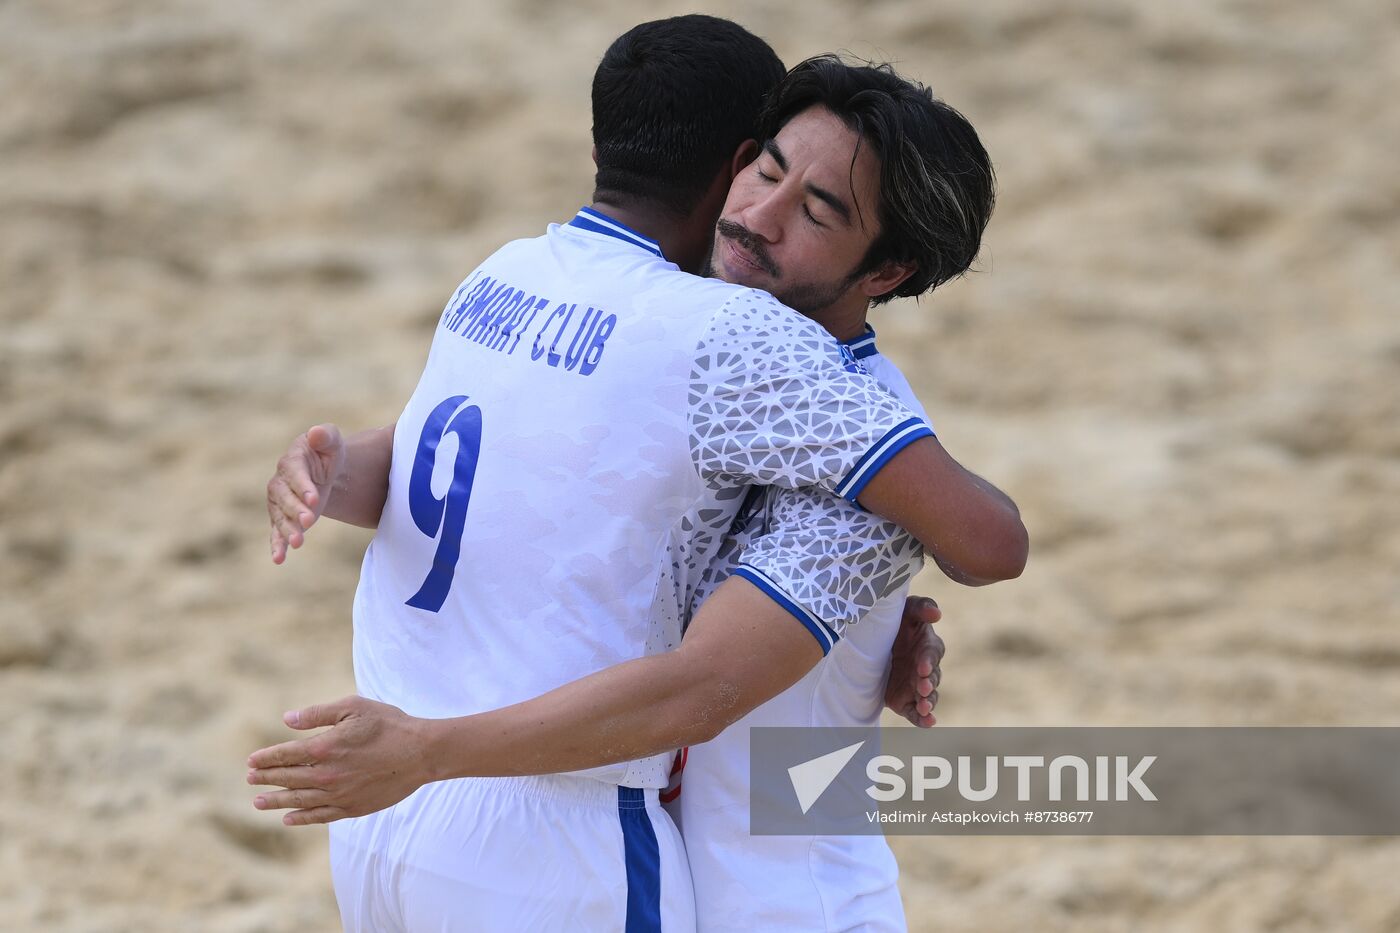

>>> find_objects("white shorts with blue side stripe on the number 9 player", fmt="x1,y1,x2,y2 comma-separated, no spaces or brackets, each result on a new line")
330,775,694,933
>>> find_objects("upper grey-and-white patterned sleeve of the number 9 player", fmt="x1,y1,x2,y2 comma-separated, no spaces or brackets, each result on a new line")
689,290,932,502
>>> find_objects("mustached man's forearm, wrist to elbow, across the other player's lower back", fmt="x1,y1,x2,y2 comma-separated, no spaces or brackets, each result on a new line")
426,651,743,780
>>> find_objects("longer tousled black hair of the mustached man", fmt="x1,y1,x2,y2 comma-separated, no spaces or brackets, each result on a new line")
760,55,995,304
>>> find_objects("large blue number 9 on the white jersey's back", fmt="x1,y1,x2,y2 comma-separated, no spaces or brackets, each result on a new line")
407,395,482,612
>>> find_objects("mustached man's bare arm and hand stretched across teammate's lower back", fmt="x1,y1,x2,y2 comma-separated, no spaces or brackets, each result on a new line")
248,577,822,825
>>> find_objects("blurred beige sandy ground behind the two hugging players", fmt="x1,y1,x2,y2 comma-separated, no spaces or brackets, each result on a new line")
0,0,1400,932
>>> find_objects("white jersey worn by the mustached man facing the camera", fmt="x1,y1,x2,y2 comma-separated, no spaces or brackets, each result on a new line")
677,340,923,933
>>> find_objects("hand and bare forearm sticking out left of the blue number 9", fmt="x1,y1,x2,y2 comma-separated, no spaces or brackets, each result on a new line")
267,424,393,563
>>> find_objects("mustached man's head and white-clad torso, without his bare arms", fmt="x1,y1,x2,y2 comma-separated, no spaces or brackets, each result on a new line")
676,56,994,933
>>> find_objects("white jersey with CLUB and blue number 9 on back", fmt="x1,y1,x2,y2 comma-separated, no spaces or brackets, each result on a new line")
354,209,931,787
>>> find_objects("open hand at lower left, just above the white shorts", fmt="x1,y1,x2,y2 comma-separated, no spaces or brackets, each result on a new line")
248,696,430,827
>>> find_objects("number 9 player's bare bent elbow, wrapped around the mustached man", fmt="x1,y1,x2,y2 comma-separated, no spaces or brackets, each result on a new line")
860,437,1030,586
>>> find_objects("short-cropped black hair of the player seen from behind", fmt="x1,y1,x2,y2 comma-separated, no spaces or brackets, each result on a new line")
594,14,784,213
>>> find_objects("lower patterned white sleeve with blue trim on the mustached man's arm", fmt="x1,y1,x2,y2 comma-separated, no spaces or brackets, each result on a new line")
732,488,924,654
